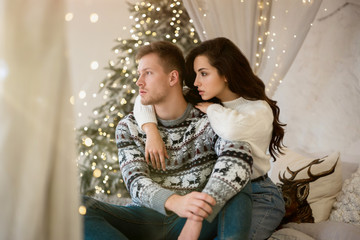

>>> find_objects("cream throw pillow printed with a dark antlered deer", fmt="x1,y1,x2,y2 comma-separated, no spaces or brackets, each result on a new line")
270,149,342,224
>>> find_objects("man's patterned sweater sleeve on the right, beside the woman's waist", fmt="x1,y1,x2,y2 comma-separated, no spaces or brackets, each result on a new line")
203,134,253,222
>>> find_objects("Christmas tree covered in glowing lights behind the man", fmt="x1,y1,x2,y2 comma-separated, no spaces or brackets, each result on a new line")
77,0,199,202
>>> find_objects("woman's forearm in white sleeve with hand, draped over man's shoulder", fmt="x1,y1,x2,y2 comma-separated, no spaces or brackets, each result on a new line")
134,96,169,171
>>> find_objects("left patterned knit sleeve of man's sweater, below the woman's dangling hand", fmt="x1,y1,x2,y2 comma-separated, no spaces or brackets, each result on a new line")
115,120,174,215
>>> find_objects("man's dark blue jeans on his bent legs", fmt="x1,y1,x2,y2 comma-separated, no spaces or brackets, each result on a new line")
83,184,252,240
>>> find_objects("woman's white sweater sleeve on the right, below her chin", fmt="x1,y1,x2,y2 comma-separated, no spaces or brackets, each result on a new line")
207,103,273,141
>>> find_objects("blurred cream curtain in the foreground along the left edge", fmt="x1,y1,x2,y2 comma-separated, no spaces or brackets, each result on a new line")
0,0,82,240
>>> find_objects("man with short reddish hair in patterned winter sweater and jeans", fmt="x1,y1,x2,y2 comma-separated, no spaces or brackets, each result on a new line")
84,41,252,240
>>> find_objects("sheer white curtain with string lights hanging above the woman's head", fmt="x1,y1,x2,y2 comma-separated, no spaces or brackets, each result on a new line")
183,0,321,97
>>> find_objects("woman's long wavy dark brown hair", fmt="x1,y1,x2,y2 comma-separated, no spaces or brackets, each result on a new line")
185,37,286,160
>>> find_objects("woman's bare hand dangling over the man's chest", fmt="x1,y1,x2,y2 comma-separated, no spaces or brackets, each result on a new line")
142,123,169,171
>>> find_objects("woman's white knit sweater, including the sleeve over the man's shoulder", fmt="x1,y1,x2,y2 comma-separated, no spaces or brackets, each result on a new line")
134,96,274,179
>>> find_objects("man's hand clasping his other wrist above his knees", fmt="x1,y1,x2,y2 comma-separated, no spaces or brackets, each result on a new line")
165,192,216,221
